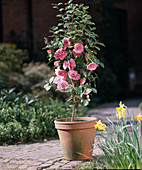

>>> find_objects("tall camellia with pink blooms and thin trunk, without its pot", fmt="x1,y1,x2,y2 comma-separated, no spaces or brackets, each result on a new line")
44,0,104,121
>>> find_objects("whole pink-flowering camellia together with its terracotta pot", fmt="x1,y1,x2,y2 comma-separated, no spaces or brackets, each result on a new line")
44,0,104,160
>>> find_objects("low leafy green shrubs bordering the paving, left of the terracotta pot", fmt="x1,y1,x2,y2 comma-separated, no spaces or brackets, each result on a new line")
0,89,85,145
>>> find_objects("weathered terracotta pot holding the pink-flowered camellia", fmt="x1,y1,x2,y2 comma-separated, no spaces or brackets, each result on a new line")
54,117,97,160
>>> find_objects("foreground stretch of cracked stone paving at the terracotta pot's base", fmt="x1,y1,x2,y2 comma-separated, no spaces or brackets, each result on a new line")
0,137,100,170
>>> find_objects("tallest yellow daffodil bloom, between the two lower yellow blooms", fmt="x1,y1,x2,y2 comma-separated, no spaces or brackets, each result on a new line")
116,101,127,119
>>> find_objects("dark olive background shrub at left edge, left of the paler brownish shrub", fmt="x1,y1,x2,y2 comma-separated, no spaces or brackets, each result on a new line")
0,43,28,88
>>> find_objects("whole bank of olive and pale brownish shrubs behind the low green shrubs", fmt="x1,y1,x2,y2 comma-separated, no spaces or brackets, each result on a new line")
0,43,65,100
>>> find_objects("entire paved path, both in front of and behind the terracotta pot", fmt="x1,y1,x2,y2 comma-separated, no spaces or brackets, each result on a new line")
0,99,142,170
